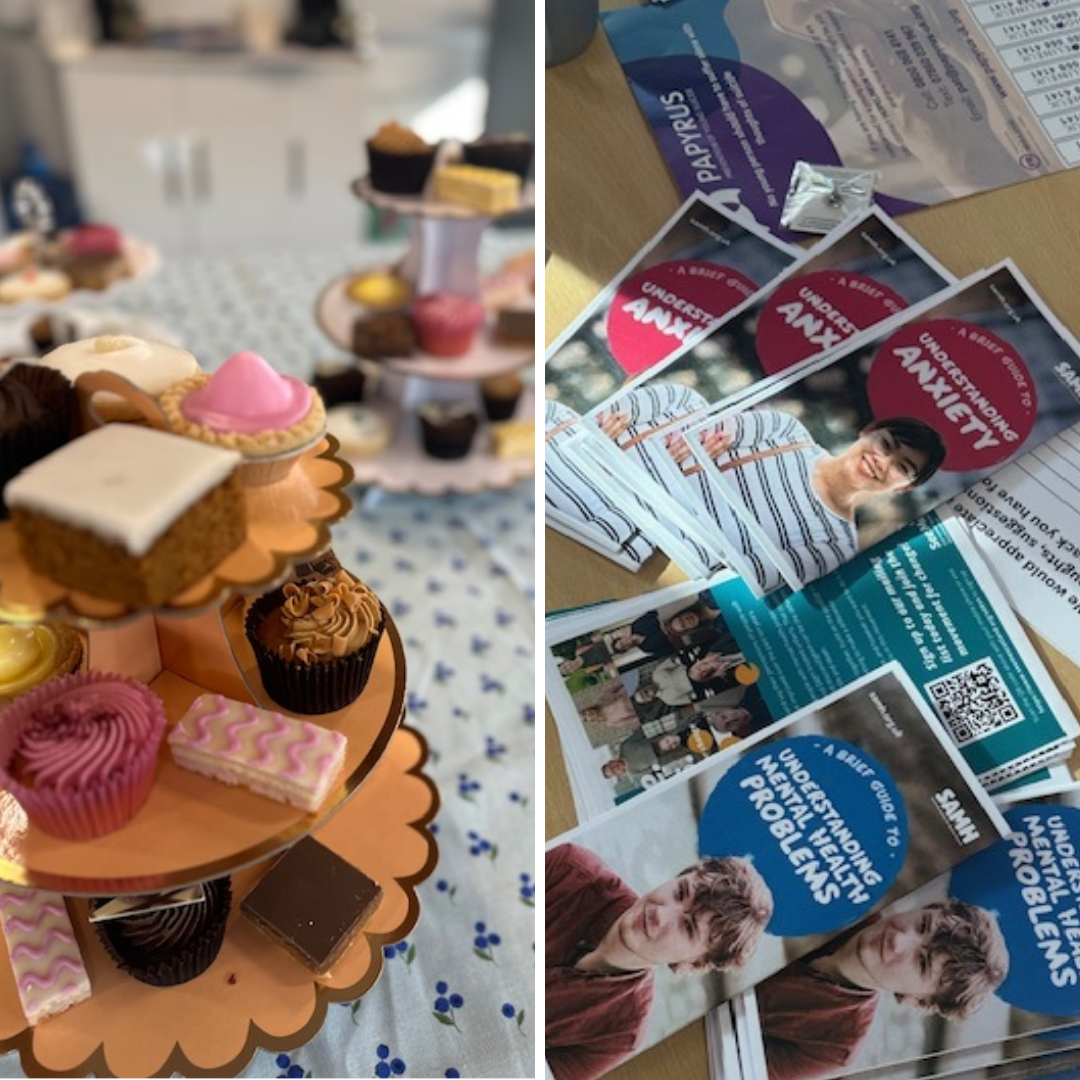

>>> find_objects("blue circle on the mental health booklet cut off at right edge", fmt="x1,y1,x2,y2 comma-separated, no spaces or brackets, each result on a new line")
949,804,1080,1017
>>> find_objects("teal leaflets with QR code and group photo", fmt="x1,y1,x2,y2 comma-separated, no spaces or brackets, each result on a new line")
545,514,1080,821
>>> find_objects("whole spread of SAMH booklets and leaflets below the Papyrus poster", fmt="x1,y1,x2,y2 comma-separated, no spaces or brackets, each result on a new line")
545,195,1080,1080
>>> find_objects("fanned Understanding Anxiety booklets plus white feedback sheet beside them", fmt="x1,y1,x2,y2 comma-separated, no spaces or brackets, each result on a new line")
545,195,1080,651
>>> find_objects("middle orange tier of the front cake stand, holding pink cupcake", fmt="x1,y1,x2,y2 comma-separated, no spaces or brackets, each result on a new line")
0,597,405,895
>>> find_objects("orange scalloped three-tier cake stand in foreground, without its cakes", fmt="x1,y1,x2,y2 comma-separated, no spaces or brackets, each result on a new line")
0,437,437,1076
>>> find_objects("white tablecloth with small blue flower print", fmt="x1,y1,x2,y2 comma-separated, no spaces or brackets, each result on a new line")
0,230,537,1077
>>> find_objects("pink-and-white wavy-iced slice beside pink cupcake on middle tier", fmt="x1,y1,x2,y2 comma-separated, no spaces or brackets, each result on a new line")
168,693,346,812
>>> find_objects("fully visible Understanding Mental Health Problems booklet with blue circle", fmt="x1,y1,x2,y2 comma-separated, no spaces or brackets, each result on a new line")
544,665,1005,1080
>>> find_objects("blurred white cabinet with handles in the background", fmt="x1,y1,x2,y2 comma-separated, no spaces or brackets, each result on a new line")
62,56,373,254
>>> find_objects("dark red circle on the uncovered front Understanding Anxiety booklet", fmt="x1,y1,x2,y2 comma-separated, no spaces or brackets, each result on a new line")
866,319,1038,472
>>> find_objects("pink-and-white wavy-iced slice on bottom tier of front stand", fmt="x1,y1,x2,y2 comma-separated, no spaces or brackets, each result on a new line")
0,883,90,1024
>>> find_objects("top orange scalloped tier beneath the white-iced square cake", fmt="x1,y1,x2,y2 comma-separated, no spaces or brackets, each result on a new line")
0,435,353,623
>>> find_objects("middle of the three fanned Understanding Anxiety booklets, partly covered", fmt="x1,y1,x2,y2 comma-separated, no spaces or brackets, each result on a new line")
571,210,955,576
